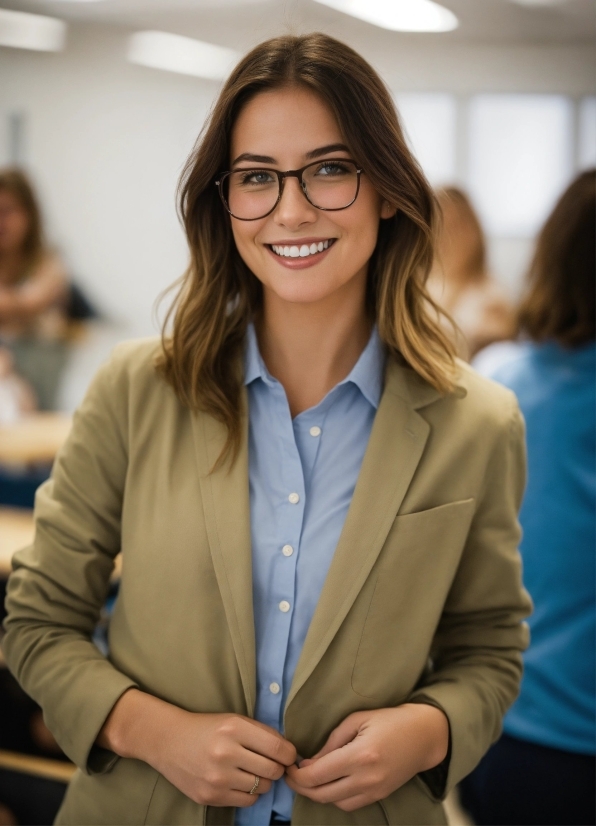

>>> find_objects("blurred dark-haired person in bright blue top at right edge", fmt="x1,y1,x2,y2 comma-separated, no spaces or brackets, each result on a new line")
462,170,596,826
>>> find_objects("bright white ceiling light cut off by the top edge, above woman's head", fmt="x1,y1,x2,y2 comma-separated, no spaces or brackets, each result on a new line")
315,0,459,32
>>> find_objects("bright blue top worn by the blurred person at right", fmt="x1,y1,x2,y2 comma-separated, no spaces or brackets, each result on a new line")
474,343,596,754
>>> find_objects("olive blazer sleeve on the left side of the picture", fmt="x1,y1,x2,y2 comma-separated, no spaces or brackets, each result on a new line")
3,348,139,773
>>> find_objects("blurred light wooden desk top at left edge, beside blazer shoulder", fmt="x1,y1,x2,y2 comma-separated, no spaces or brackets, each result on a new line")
0,413,72,466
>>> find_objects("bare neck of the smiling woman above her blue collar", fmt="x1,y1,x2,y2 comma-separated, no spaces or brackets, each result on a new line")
256,280,372,417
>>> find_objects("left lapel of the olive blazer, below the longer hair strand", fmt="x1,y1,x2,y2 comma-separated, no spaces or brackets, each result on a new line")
193,392,256,716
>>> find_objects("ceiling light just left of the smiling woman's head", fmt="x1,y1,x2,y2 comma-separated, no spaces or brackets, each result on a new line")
128,32,240,80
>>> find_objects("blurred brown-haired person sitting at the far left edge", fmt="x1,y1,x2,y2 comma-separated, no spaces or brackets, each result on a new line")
0,169,69,410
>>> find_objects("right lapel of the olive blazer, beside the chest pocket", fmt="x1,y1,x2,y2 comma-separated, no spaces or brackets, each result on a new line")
286,361,439,709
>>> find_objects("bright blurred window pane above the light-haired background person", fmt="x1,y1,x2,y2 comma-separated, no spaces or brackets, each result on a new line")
468,94,574,237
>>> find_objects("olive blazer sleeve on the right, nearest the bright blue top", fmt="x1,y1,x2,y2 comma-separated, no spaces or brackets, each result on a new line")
410,394,532,798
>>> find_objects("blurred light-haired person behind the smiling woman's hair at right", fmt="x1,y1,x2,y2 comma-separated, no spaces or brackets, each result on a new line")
427,186,515,361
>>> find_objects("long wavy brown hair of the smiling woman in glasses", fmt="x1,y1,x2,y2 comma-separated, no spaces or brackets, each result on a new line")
158,33,454,459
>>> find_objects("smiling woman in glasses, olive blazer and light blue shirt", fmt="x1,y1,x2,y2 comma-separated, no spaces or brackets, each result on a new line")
5,34,529,824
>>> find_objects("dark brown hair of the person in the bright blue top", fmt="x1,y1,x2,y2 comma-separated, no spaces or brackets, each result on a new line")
519,169,596,347
